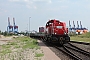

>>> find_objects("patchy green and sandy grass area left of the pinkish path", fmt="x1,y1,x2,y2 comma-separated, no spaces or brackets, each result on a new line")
0,37,44,60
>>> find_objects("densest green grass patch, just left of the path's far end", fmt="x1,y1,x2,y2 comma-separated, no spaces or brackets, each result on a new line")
16,37,39,49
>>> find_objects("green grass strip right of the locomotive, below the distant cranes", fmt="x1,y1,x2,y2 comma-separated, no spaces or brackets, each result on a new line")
70,32,90,43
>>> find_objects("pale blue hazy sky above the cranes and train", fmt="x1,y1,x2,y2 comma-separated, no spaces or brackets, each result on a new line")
0,0,90,31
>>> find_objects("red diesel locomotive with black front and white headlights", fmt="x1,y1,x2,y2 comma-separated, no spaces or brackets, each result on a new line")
44,19,70,44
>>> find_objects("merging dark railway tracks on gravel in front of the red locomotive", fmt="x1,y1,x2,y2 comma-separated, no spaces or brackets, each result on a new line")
49,43,90,60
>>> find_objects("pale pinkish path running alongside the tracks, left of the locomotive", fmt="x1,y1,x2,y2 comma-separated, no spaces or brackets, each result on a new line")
38,40,61,60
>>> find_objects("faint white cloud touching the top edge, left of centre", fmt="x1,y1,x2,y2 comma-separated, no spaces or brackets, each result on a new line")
9,0,52,9
